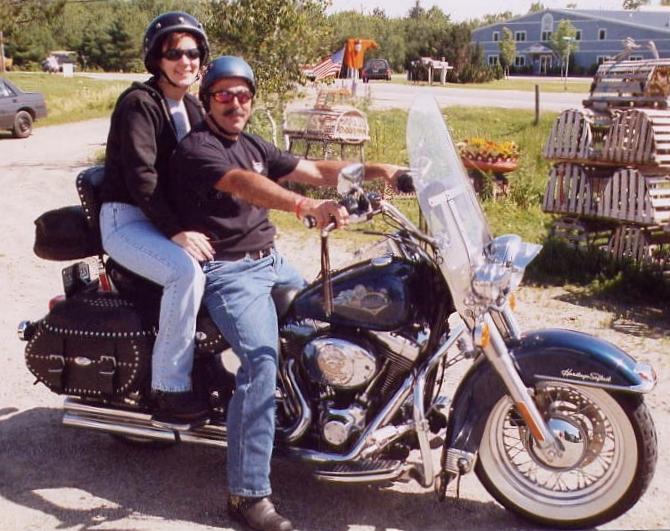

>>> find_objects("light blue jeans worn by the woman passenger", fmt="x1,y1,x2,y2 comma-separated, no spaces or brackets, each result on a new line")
100,203,205,392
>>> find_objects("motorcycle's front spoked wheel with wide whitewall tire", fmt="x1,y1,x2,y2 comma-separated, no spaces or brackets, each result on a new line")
476,382,657,528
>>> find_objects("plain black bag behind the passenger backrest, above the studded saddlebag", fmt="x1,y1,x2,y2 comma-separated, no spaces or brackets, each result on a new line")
33,206,103,260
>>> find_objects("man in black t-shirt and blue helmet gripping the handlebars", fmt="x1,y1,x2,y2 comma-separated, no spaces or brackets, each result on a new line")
170,56,402,530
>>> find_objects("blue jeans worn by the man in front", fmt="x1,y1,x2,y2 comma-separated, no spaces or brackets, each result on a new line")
203,251,305,496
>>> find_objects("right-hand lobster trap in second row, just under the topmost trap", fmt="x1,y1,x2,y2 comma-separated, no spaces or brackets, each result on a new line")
601,109,670,167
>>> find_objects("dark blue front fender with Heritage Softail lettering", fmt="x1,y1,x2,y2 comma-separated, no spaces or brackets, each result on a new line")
445,329,656,453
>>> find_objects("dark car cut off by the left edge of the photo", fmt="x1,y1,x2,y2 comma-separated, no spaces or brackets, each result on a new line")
0,77,47,138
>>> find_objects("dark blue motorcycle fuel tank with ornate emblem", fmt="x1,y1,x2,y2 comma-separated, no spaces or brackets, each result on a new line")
293,256,430,331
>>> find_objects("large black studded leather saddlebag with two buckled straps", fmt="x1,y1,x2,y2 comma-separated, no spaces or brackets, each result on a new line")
26,286,155,399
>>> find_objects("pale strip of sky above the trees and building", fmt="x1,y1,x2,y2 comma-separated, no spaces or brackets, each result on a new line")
328,0,659,22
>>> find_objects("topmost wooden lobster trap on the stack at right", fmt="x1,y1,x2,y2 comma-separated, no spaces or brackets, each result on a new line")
583,59,670,109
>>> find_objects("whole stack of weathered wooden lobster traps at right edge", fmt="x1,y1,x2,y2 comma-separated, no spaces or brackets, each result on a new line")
543,59,670,271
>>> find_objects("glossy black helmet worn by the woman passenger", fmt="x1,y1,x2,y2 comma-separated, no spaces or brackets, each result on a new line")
142,11,209,75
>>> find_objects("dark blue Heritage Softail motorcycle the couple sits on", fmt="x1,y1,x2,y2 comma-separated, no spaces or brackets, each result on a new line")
19,101,657,528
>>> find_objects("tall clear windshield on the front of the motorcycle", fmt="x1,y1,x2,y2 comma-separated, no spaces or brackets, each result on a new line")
407,98,491,312
